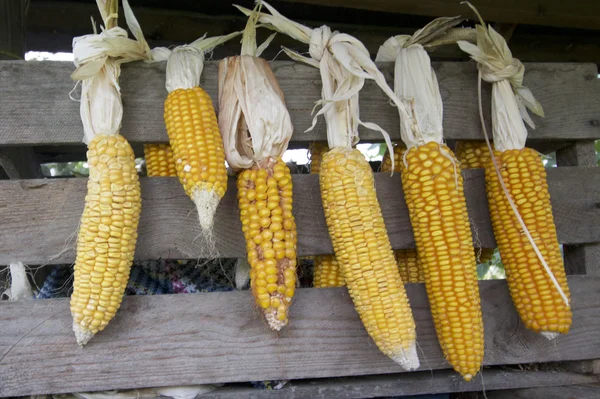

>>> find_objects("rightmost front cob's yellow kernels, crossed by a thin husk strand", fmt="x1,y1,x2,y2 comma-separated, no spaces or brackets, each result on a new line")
485,148,572,336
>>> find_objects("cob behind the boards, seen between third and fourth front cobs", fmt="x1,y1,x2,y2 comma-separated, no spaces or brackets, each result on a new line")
309,141,344,288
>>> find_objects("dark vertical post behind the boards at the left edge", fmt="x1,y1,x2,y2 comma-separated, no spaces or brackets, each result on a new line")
0,0,42,179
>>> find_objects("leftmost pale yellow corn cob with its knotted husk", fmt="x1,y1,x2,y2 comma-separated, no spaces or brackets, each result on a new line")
71,0,149,345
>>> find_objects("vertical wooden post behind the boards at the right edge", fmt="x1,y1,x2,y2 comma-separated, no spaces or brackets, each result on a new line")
556,140,600,276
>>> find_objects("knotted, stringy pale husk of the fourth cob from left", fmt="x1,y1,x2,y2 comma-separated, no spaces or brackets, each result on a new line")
238,2,410,162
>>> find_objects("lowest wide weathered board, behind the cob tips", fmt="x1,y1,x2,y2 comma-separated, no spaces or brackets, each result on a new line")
0,276,600,396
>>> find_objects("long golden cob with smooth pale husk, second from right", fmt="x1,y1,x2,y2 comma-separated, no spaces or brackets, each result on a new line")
377,17,483,381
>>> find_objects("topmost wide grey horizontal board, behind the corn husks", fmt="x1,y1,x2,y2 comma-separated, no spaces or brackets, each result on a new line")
0,61,600,145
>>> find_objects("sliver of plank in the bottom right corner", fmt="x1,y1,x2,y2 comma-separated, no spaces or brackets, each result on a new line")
482,383,600,399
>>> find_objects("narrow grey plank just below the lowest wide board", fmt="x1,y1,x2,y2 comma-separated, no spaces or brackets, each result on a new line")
202,368,598,399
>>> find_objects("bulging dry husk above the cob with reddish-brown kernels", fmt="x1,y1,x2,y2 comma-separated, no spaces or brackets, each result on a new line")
218,5,294,170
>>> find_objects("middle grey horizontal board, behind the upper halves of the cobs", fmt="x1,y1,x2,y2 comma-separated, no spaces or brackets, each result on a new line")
0,167,600,264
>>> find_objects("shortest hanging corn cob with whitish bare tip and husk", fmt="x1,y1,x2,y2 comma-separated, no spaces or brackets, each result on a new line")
164,32,239,257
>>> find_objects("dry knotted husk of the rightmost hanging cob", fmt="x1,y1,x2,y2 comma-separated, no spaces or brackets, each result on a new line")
458,4,544,151
